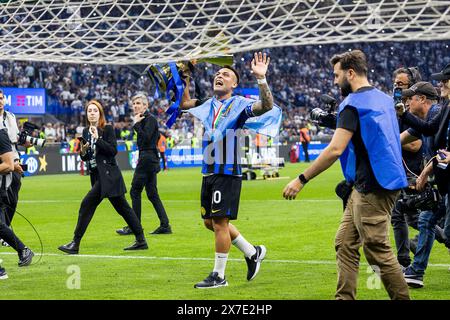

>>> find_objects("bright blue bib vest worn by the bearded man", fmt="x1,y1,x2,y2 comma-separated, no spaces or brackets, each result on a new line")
338,89,408,190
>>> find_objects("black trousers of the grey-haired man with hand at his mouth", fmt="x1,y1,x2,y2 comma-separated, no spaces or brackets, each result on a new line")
130,165,169,227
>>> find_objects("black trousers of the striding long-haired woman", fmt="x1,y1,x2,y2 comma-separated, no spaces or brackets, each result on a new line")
73,175,145,243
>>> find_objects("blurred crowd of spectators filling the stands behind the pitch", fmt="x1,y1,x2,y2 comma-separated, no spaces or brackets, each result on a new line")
0,41,450,146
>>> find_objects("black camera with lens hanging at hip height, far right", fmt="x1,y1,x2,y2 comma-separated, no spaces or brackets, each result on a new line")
398,183,441,211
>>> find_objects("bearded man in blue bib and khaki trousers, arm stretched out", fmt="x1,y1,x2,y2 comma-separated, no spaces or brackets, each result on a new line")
283,50,409,300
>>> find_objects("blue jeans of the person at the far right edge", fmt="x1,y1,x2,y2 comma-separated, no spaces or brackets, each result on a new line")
412,195,450,275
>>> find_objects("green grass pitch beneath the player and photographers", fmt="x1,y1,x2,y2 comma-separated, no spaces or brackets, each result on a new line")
0,164,450,300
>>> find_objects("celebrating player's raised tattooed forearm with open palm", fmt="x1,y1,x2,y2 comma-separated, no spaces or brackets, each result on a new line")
252,52,273,116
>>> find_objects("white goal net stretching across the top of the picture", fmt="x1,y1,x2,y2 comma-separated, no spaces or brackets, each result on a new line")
0,0,450,65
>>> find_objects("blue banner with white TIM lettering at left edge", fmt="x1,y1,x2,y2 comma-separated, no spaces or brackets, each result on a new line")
0,87,46,114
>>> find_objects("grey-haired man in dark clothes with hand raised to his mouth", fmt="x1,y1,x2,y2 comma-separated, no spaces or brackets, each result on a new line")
116,94,172,235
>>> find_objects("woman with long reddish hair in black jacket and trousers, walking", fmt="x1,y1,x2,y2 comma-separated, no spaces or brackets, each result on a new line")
58,100,148,254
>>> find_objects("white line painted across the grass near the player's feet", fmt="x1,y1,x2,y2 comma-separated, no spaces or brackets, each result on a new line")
0,252,450,268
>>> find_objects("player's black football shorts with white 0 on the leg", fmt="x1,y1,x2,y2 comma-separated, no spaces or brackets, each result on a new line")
201,174,242,220
